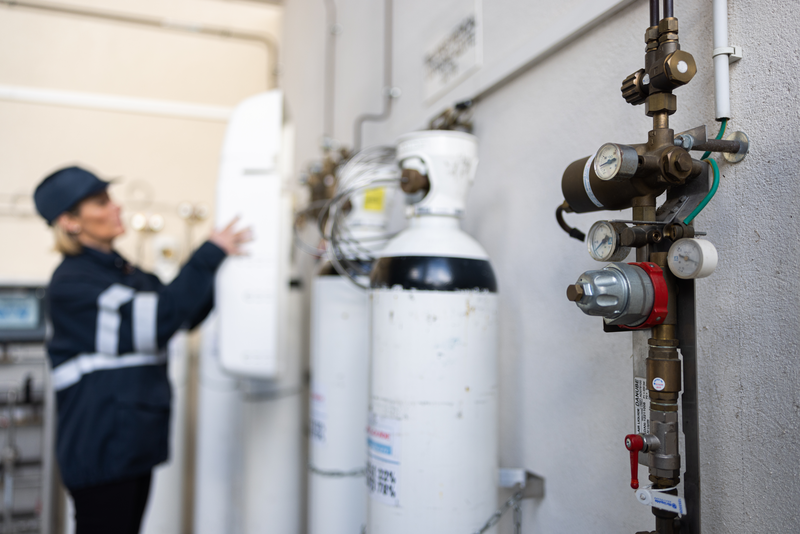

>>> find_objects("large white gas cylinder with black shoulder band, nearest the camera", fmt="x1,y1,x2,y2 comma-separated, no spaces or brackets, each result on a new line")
367,131,498,534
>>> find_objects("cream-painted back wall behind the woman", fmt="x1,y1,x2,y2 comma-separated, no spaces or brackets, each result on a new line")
0,0,282,278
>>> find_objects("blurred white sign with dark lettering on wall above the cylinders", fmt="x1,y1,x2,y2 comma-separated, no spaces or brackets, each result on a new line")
423,0,483,100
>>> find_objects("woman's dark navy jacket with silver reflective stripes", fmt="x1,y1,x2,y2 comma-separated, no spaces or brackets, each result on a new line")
48,243,225,489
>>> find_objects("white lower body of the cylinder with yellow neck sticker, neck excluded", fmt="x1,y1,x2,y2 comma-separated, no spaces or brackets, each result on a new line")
308,274,369,534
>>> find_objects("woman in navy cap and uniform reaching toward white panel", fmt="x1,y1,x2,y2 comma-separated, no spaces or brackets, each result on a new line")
34,167,249,534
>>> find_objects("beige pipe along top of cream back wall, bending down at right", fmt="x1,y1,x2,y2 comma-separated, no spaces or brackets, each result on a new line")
0,0,278,89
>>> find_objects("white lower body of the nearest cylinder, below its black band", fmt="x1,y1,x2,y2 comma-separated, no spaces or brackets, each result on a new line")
367,286,498,534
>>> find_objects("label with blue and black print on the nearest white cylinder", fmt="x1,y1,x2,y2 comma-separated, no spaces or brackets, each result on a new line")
367,414,400,506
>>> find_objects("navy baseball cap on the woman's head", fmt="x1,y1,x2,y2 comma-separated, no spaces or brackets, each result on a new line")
33,167,110,226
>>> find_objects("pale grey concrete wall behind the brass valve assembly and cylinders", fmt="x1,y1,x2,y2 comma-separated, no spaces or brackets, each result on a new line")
284,0,800,534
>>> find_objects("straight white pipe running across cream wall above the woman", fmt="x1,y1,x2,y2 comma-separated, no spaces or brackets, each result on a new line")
0,85,232,122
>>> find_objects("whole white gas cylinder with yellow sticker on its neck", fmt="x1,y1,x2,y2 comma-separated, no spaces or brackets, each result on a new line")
308,151,399,534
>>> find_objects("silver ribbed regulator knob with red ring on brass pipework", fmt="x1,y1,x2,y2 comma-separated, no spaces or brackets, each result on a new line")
567,262,668,329
